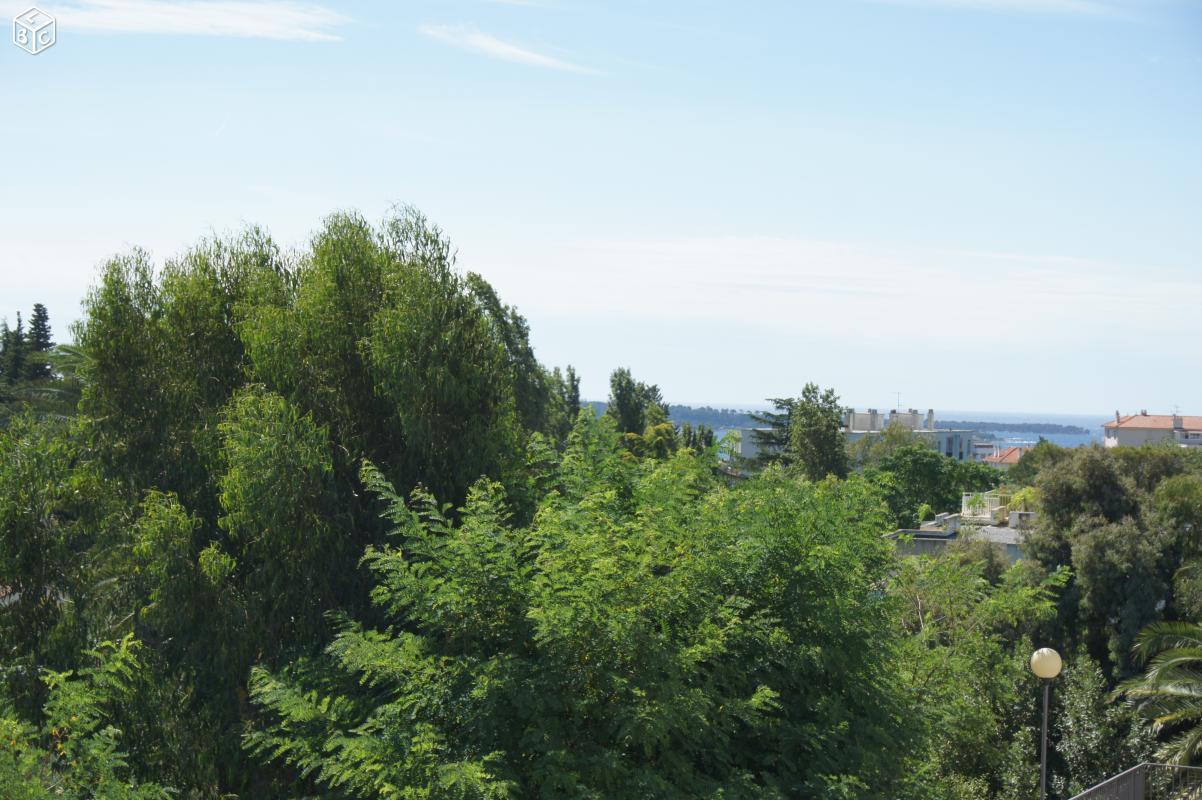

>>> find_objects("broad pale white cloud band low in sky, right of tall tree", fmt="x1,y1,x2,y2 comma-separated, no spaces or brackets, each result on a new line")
473,237,1202,350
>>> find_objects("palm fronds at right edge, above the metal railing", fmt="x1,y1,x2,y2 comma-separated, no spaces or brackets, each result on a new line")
1114,622,1202,764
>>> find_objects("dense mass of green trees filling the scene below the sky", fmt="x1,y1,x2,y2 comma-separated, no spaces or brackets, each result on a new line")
0,209,1187,800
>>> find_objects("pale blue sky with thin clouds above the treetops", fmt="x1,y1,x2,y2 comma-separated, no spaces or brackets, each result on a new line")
0,0,1202,414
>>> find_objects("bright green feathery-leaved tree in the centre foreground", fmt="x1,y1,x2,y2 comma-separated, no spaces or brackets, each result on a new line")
248,414,905,798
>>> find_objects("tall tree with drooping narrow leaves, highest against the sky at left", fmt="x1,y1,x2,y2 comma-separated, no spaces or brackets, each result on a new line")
61,209,552,796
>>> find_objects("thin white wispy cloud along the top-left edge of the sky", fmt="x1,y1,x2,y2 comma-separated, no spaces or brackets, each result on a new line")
18,0,350,42
